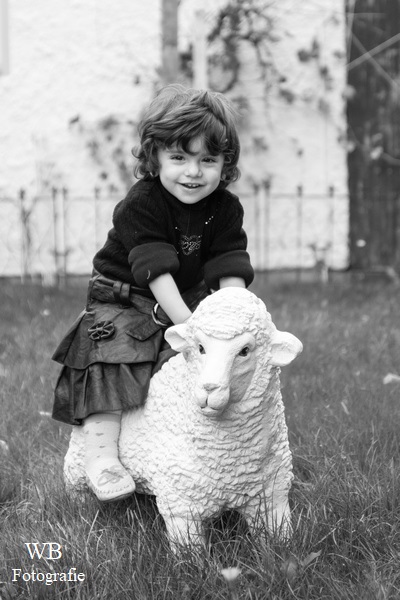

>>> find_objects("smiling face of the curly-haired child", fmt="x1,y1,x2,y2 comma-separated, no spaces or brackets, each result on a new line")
158,137,224,204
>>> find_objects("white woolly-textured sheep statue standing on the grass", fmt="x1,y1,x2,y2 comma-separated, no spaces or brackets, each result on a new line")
64,288,302,544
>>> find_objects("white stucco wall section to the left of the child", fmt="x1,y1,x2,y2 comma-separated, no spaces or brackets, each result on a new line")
0,0,161,277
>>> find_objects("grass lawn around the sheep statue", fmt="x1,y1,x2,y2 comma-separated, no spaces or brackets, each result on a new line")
0,278,400,600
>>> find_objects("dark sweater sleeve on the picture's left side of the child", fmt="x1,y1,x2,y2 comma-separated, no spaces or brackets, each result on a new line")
113,185,179,287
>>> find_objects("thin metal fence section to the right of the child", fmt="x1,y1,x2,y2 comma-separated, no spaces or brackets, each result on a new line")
241,186,349,270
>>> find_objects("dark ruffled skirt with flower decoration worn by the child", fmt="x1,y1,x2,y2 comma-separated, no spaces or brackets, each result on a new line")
53,278,208,425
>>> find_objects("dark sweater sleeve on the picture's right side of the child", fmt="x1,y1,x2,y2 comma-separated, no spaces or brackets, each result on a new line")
204,193,254,289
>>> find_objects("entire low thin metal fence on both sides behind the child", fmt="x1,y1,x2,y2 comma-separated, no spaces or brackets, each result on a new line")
0,187,348,283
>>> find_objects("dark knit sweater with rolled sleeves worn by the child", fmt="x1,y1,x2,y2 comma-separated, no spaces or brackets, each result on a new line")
93,177,254,292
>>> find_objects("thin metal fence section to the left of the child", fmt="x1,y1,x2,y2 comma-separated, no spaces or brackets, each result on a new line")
0,188,119,281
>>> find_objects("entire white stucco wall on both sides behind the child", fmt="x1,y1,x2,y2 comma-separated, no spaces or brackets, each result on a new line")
0,0,348,274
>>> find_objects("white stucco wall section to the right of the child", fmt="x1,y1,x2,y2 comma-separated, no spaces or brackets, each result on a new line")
180,0,349,269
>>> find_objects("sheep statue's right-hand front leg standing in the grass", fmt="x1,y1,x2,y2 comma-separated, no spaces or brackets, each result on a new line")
241,494,292,539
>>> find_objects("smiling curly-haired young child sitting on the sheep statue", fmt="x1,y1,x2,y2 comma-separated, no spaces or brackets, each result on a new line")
53,85,253,501
